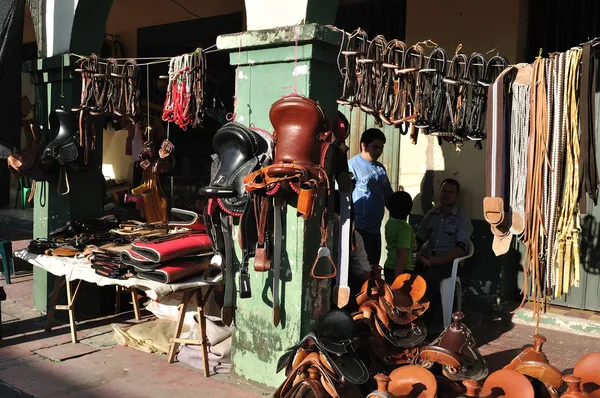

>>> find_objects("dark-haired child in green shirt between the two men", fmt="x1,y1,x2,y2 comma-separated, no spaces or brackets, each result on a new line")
383,191,417,284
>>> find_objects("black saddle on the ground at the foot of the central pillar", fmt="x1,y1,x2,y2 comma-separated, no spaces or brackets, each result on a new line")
277,309,369,384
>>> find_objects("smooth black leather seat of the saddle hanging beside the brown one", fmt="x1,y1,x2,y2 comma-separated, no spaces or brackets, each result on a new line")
200,122,261,198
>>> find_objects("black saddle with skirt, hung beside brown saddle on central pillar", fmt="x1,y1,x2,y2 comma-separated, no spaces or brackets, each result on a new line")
200,122,272,216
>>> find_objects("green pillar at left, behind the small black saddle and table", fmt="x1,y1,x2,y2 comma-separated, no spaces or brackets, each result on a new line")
26,55,104,316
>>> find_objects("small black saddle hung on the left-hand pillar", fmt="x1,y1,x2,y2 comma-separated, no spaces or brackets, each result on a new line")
42,109,79,164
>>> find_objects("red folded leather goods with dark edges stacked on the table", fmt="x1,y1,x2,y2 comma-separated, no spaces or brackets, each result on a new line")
121,232,213,283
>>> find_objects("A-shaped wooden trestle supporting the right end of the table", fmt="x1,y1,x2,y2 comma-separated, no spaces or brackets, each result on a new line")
168,285,213,377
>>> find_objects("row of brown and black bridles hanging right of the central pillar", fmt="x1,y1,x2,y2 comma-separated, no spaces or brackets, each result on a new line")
338,28,509,150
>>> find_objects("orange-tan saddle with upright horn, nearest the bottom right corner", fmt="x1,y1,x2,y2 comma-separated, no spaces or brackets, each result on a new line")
504,334,562,397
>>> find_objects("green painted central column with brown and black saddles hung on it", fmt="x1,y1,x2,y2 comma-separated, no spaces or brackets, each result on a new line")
217,24,341,387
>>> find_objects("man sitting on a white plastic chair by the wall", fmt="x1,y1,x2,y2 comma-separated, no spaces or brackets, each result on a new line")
417,178,473,333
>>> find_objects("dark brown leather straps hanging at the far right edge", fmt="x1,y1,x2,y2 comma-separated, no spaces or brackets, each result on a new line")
579,42,599,213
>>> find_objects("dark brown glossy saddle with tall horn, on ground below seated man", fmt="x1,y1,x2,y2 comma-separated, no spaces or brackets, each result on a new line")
417,311,488,381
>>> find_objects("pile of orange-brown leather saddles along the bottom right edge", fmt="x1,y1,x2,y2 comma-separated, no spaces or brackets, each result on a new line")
358,330,600,398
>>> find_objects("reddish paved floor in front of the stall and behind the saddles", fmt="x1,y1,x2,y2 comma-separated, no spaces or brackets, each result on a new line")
0,242,600,398
